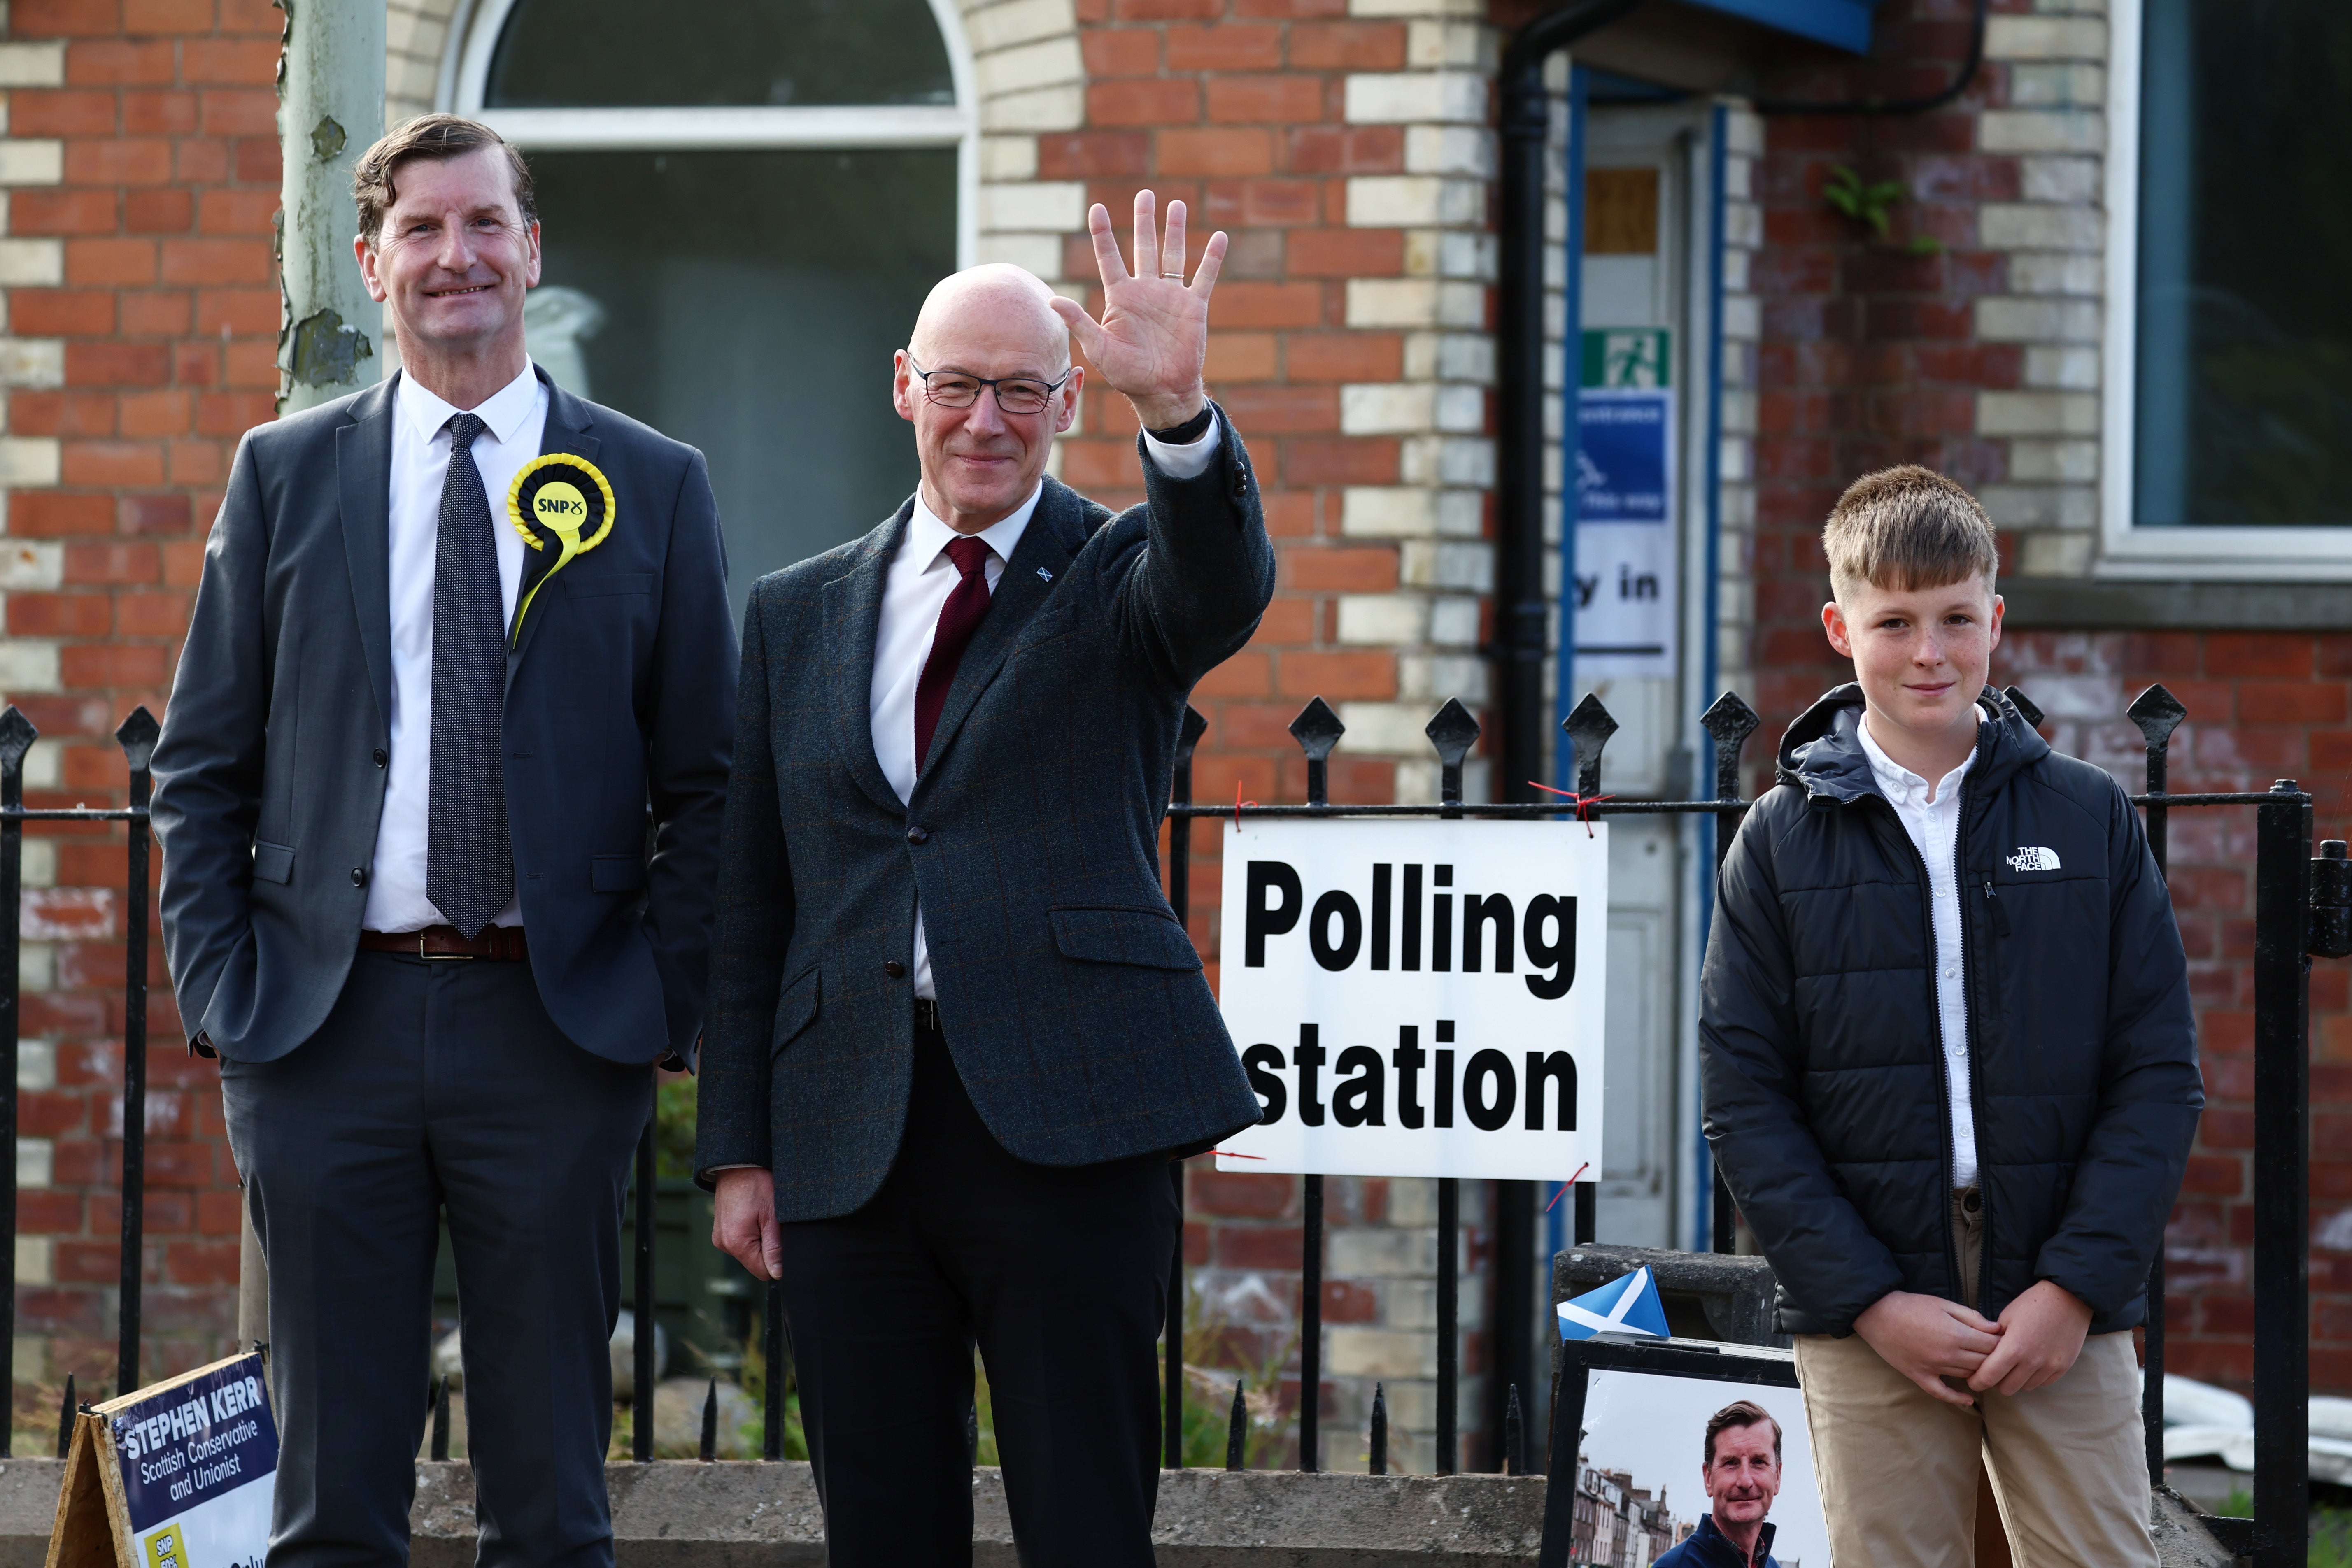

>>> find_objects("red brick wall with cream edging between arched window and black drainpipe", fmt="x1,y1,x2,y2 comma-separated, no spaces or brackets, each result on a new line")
1037,0,1493,1472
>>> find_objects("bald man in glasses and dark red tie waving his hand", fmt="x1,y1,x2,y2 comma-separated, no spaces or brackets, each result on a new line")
696,193,1275,1568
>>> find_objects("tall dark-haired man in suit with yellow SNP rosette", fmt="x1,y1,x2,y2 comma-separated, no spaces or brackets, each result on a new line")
155,115,736,1568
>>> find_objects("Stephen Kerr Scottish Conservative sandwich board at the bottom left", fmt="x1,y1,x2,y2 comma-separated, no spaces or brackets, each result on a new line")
49,1354,277,1568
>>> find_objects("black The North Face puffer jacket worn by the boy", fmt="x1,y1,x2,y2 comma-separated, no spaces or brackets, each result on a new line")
1698,686,2204,1335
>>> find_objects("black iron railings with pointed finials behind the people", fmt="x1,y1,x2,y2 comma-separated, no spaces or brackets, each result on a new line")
0,686,2352,1568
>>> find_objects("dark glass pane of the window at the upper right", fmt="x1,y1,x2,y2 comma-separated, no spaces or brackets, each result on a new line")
2133,0,2352,527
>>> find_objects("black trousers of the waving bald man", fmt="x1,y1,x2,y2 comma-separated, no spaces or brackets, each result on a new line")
783,1030,1178,1568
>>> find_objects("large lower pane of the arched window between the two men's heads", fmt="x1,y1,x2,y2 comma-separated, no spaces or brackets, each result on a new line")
529,148,955,618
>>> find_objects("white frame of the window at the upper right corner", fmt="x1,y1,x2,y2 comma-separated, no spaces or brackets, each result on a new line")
2098,0,2352,581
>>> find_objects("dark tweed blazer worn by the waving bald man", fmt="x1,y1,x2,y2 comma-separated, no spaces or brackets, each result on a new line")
694,412,1275,1220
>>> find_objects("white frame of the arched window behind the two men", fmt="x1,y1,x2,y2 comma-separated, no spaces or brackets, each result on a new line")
438,0,981,268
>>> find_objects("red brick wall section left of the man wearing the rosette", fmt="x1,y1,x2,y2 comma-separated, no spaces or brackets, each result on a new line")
0,0,282,1420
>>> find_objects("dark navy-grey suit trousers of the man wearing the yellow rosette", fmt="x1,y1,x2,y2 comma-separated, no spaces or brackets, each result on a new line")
221,952,652,1568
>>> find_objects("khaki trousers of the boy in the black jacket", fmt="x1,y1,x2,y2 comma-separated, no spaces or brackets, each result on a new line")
1797,1189,2157,1568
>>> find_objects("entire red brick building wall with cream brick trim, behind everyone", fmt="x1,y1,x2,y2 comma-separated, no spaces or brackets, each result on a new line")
0,0,2324,1438
